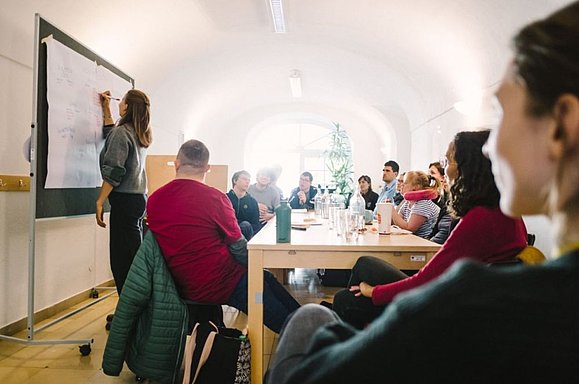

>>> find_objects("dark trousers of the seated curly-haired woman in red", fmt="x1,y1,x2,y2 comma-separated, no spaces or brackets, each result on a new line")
332,256,408,329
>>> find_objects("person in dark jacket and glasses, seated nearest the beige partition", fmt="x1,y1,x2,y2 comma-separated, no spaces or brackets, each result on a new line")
227,171,261,241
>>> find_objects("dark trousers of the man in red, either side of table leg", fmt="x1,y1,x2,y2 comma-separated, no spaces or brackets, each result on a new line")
227,271,300,333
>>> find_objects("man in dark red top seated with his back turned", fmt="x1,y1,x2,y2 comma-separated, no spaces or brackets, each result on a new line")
147,140,299,333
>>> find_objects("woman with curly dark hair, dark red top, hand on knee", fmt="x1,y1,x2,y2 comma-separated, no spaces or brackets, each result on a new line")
333,131,527,328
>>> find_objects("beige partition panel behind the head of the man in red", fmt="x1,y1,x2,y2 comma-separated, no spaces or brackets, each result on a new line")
146,155,228,196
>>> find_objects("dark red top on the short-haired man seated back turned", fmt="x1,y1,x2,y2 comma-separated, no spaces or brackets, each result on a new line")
147,179,247,304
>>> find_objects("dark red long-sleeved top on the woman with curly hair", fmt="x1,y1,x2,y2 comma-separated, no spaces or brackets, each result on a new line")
372,207,527,305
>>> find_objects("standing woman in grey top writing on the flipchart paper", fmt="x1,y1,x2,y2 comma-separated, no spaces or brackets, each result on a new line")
96,89,152,294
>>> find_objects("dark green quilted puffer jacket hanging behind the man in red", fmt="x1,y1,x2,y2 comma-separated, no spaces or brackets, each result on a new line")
103,231,189,383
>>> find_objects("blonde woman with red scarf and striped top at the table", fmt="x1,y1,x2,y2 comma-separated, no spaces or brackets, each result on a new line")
392,171,440,237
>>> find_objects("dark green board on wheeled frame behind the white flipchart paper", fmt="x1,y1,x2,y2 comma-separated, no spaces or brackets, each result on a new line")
30,14,135,219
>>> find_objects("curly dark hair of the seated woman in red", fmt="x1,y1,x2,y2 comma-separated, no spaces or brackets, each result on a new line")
448,130,500,217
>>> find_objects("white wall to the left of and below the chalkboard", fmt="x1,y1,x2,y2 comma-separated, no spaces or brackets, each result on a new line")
0,13,111,327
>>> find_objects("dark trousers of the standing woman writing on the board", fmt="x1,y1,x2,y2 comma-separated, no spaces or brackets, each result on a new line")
109,192,146,295
